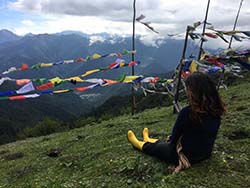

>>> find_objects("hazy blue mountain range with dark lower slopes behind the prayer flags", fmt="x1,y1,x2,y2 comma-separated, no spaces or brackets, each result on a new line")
0,30,195,144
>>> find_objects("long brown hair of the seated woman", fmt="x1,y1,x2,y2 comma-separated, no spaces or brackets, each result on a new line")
185,72,226,123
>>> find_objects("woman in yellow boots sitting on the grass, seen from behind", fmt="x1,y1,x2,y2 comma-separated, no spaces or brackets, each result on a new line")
128,72,226,171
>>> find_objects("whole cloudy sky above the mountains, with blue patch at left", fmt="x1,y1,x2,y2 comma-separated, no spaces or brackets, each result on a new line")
0,0,250,47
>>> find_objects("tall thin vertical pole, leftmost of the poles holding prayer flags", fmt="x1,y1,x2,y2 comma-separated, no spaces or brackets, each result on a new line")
131,0,136,115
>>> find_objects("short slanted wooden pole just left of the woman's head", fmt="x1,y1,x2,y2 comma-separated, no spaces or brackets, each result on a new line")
173,26,190,113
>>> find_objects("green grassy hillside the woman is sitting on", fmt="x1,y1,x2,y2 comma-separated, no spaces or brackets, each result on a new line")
0,82,250,188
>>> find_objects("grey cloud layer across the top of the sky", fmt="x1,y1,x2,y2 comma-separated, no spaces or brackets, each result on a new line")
9,0,250,29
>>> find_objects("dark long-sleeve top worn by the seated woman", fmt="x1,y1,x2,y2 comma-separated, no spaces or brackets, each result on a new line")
170,106,221,162
